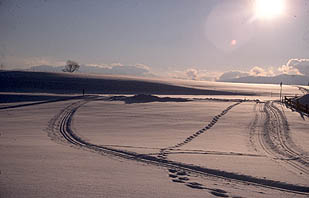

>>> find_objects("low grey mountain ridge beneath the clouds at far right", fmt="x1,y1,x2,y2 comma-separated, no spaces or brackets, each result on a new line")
218,74,309,85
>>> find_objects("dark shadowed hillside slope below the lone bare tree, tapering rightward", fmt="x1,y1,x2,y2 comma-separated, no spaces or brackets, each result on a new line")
0,71,248,95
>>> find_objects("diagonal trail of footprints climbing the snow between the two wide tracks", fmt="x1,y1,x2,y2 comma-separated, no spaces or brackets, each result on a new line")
158,102,241,159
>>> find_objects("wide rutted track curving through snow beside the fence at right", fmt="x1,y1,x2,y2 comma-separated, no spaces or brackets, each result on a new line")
250,101,309,175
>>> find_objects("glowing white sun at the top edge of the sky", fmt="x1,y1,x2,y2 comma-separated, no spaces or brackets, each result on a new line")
255,0,285,19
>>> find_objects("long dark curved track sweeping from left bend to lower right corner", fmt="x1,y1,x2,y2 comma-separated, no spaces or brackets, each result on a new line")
48,97,309,195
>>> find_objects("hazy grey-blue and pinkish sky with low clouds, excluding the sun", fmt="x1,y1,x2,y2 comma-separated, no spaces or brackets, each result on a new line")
0,0,309,78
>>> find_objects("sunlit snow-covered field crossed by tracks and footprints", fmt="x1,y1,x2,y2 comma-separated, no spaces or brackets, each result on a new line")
0,73,309,198
